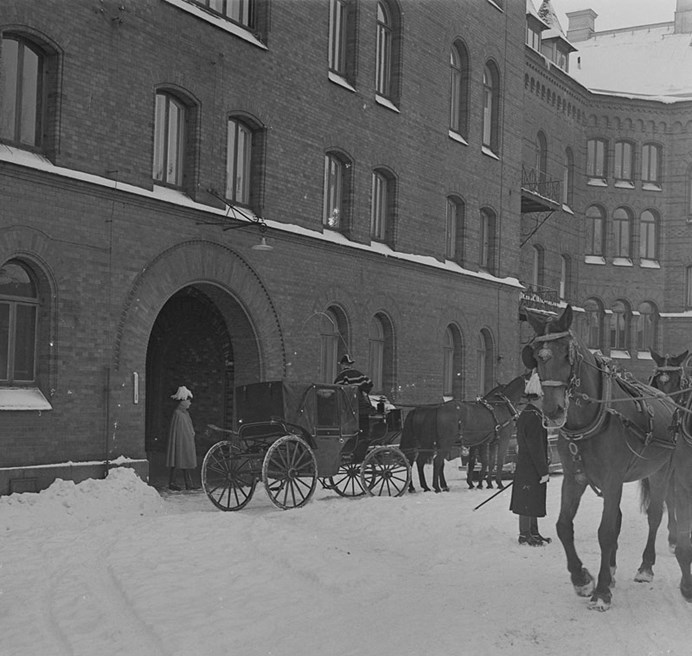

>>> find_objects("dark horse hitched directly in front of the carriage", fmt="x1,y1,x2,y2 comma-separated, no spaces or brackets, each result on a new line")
399,376,525,492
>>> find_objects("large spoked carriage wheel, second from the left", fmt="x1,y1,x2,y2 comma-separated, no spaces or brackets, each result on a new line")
262,435,317,510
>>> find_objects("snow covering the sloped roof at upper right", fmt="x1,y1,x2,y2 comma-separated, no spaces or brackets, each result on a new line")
570,22,692,103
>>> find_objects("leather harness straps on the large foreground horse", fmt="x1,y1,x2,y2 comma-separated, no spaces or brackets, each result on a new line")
534,327,680,496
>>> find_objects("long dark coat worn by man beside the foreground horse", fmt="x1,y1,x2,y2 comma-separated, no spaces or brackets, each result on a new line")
509,403,549,517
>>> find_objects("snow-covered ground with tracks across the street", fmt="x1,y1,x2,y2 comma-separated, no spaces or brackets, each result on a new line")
0,461,692,656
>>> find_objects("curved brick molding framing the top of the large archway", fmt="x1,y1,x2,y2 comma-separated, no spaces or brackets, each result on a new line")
113,240,286,379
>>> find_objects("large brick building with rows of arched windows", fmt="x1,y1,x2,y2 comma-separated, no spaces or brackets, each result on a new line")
0,0,689,494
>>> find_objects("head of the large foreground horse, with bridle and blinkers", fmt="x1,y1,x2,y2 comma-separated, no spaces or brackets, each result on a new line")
522,305,577,428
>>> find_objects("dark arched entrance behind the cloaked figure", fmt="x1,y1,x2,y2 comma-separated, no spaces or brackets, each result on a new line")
145,283,259,487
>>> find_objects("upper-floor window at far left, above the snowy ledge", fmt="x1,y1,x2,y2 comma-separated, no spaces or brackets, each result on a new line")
0,35,44,147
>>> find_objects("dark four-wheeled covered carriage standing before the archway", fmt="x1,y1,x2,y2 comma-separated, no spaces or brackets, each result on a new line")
202,381,411,510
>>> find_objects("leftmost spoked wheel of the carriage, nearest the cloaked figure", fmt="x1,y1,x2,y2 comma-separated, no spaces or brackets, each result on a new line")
202,441,257,510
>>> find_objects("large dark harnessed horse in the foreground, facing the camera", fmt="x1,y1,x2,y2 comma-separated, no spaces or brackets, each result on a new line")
522,305,680,610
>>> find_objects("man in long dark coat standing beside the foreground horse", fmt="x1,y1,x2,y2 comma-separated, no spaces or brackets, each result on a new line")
509,371,550,547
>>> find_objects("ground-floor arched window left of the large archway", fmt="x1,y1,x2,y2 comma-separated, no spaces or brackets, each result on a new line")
0,260,39,385
